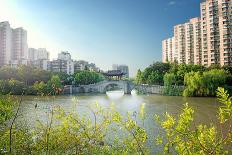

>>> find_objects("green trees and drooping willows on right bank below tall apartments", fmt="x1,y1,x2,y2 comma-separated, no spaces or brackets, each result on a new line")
135,62,232,96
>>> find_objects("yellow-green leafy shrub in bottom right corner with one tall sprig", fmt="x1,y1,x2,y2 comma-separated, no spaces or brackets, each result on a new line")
155,88,232,154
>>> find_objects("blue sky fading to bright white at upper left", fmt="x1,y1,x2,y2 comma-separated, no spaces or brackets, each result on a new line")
0,0,200,77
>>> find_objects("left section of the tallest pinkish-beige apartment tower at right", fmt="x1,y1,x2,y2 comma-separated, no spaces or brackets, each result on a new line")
201,0,220,66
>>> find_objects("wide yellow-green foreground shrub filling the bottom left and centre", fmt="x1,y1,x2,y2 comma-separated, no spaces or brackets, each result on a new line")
0,102,148,154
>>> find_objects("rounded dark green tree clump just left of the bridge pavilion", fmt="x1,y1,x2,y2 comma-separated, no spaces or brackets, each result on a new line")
75,70,104,85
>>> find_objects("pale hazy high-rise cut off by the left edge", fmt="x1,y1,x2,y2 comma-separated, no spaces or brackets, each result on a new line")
0,22,12,66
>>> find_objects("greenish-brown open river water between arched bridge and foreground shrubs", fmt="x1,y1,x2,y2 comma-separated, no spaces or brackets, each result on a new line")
19,91,220,153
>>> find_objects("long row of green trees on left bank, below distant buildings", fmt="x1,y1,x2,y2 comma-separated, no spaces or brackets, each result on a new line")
0,65,104,95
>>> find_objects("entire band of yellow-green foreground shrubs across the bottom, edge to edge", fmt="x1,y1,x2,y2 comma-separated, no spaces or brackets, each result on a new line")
0,88,232,155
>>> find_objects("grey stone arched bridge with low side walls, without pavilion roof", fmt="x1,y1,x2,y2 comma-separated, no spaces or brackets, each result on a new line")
64,80,183,94
